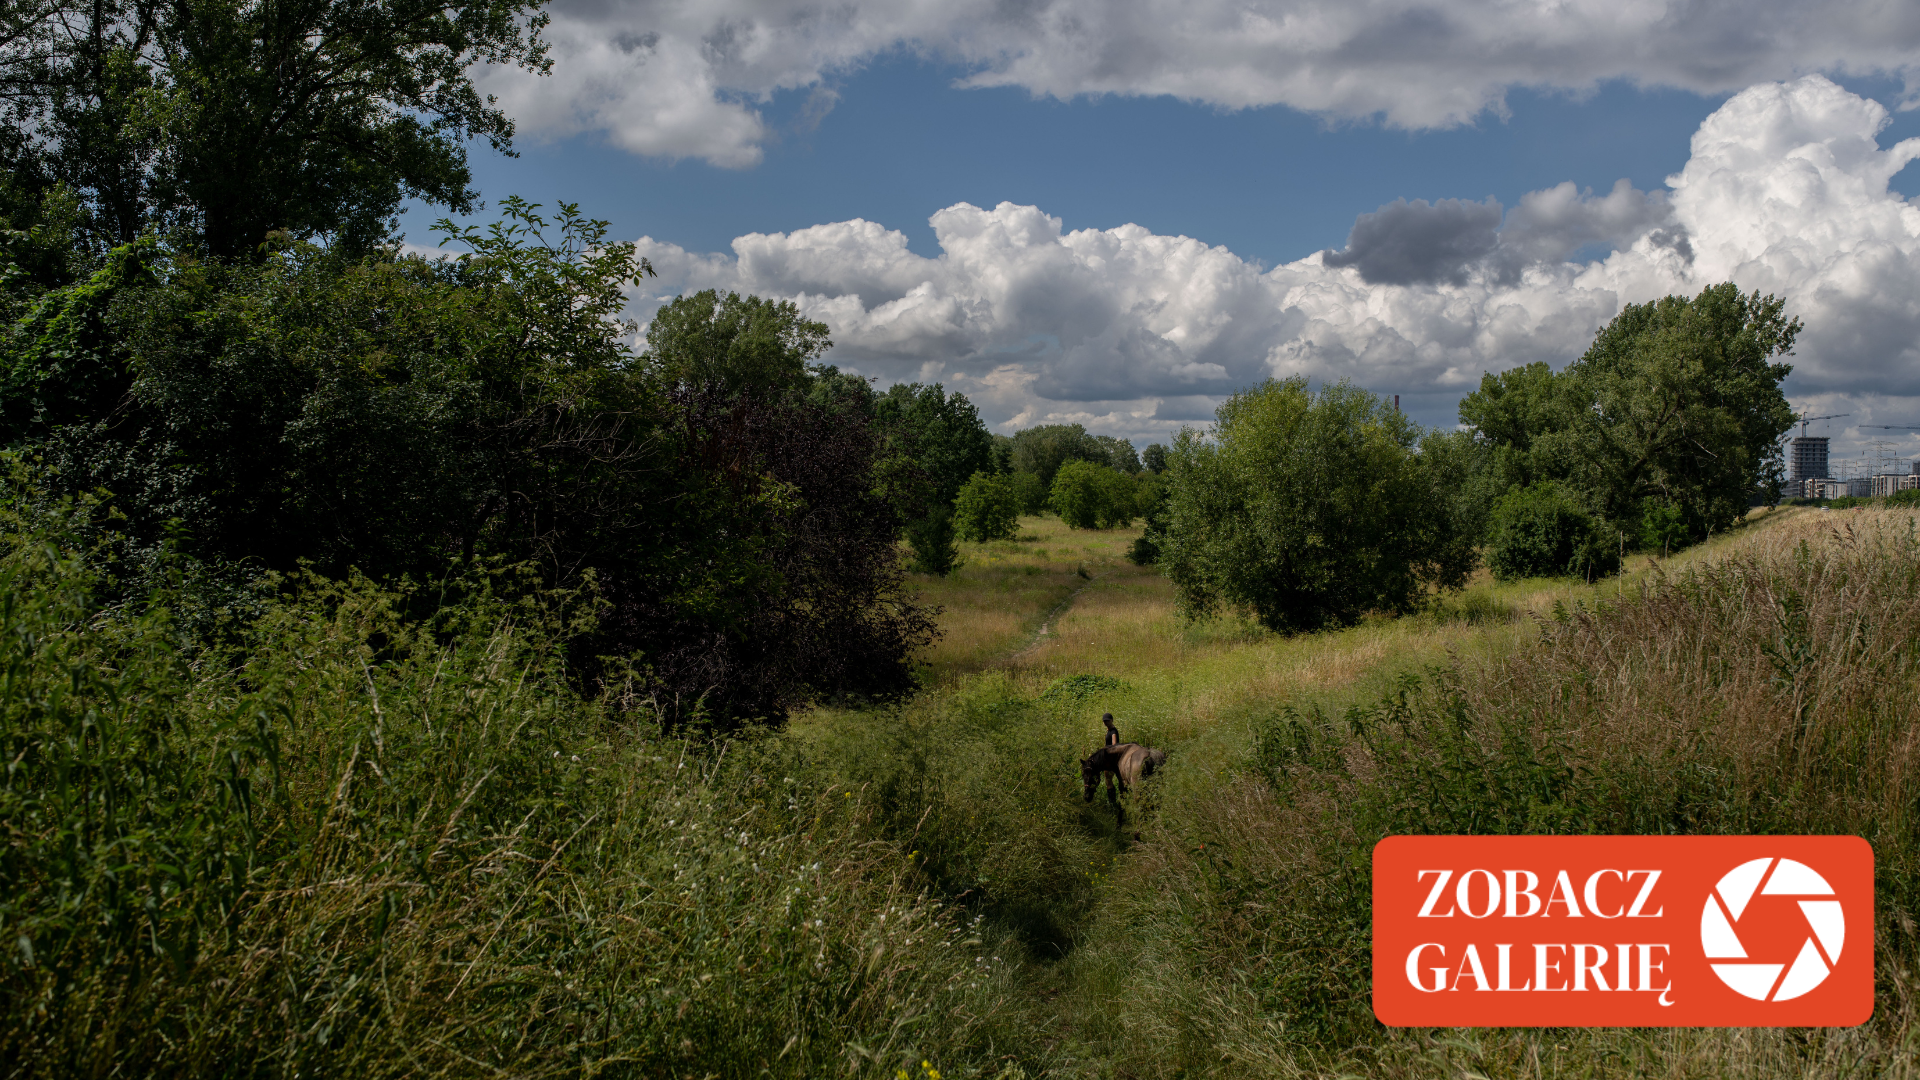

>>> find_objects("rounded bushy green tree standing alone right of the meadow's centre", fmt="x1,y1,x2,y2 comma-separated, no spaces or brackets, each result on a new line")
1160,377,1473,630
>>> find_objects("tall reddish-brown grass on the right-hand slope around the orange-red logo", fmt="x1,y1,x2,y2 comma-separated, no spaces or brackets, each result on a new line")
1075,513,1920,1076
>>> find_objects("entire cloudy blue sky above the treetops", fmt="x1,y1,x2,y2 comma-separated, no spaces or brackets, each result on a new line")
403,0,1920,459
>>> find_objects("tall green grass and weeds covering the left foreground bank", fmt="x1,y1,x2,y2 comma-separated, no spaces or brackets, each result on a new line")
0,518,1018,1076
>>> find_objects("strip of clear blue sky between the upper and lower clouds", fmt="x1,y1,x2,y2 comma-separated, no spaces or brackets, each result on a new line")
403,65,1920,265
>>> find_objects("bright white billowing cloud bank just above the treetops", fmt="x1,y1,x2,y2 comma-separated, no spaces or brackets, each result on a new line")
636,75,1920,452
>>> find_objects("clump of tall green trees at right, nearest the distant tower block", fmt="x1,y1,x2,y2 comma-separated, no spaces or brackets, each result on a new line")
1459,284,1801,550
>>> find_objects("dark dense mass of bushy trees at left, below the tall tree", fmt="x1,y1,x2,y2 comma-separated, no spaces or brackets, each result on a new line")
16,200,933,726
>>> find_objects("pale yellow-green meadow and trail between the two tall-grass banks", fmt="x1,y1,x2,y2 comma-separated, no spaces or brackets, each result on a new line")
793,511,1858,1076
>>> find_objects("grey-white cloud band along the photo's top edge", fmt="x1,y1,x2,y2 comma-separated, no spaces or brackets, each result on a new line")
480,0,1920,167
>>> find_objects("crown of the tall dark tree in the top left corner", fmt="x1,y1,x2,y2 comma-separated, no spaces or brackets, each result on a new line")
15,0,547,258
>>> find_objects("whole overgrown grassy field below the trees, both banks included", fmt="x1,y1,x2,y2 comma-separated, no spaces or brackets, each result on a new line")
0,509,1920,1080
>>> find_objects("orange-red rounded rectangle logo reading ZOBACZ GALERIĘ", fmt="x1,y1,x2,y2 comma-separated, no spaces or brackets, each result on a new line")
1373,836,1874,1028
